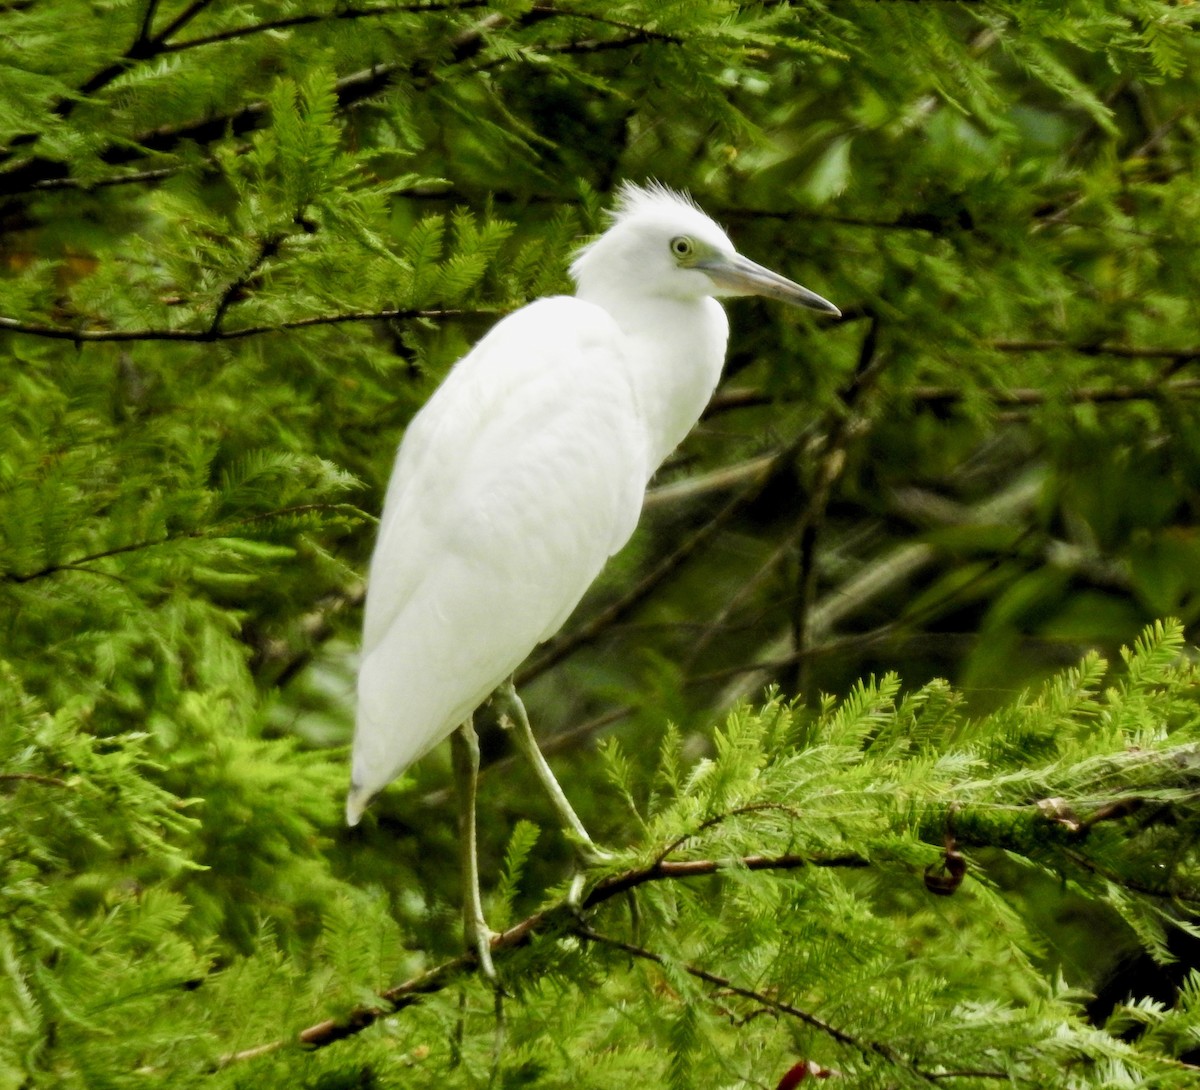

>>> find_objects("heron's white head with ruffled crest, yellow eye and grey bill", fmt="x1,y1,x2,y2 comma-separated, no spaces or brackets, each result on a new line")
571,182,841,315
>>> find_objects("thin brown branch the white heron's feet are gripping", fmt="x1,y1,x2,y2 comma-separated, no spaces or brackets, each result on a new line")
220,854,871,1066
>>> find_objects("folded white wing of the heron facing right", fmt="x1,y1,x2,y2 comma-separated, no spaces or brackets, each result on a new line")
347,297,649,824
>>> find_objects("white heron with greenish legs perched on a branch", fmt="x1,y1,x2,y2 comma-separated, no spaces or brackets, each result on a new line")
346,184,839,976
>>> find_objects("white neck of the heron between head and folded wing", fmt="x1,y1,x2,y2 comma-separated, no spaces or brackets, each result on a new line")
585,291,730,475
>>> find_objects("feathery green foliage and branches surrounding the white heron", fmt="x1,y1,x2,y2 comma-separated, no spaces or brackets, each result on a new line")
0,0,1200,1090
